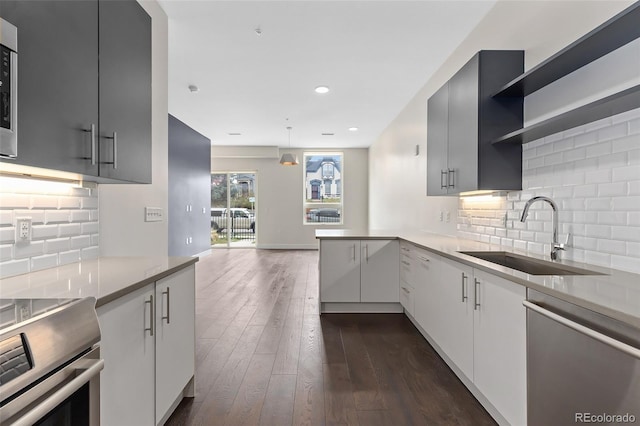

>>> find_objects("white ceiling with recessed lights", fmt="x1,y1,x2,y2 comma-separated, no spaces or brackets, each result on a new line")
160,0,495,148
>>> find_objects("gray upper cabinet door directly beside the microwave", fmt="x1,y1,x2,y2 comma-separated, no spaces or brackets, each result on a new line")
0,0,98,176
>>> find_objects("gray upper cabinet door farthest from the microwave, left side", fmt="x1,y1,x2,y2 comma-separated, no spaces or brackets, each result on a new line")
99,0,151,183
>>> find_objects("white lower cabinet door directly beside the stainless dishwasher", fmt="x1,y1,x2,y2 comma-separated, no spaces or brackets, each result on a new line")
473,269,527,425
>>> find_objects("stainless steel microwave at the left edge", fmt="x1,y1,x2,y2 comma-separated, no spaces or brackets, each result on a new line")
0,18,18,158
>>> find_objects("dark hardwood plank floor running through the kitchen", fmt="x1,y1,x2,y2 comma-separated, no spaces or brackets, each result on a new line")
167,249,495,426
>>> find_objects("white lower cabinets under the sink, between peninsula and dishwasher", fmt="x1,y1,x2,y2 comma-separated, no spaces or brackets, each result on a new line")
413,250,527,426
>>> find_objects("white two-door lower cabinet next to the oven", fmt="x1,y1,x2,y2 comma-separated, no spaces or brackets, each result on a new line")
97,265,195,426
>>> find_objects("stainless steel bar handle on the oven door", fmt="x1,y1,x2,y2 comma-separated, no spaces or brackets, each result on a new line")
12,359,104,426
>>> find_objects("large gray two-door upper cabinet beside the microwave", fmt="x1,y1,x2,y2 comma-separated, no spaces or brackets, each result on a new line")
0,0,151,183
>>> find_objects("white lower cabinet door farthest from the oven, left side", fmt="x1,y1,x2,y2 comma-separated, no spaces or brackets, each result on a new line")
155,267,195,423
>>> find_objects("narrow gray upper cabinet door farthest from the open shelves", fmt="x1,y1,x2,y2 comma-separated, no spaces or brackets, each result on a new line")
427,84,449,195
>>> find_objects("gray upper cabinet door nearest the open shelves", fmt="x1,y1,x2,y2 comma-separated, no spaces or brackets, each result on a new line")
447,55,479,194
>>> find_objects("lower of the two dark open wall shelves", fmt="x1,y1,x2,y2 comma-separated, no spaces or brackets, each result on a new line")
491,85,640,144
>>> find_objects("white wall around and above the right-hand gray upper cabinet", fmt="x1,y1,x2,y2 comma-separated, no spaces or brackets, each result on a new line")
369,1,633,235
